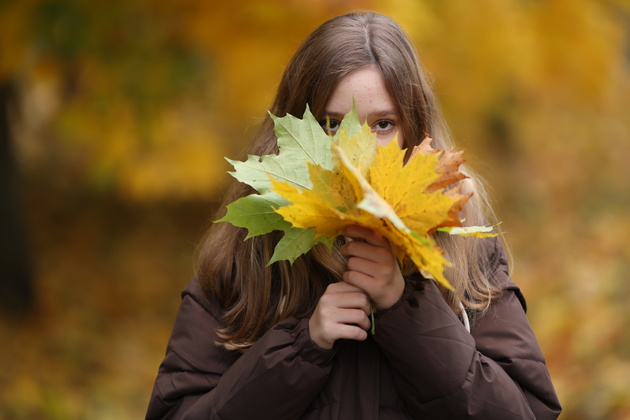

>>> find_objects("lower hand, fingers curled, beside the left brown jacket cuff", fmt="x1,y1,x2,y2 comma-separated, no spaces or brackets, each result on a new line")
308,282,371,349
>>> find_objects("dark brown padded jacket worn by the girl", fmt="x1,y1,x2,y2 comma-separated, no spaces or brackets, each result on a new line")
147,240,560,420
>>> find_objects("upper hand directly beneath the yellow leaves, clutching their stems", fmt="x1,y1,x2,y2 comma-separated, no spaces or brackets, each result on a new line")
340,226,405,310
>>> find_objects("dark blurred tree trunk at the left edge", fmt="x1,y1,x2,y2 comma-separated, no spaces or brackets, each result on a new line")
0,81,34,316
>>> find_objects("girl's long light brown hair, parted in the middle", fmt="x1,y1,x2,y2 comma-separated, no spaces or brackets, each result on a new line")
197,12,498,350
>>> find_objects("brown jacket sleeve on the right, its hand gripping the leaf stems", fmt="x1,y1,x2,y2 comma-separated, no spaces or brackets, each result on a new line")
374,240,561,420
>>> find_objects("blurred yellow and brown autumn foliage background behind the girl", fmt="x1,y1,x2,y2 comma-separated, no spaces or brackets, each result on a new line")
0,0,630,419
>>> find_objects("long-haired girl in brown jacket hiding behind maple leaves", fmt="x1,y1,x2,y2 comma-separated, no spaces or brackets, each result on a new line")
147,13,560,420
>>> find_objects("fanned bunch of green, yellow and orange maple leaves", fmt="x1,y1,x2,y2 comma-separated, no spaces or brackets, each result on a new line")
218,107,492,288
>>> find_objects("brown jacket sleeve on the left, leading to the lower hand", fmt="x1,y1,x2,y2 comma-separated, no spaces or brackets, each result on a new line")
146,280,334,419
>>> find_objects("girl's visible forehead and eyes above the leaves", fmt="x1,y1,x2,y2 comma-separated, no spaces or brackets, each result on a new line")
321,65,404,147
